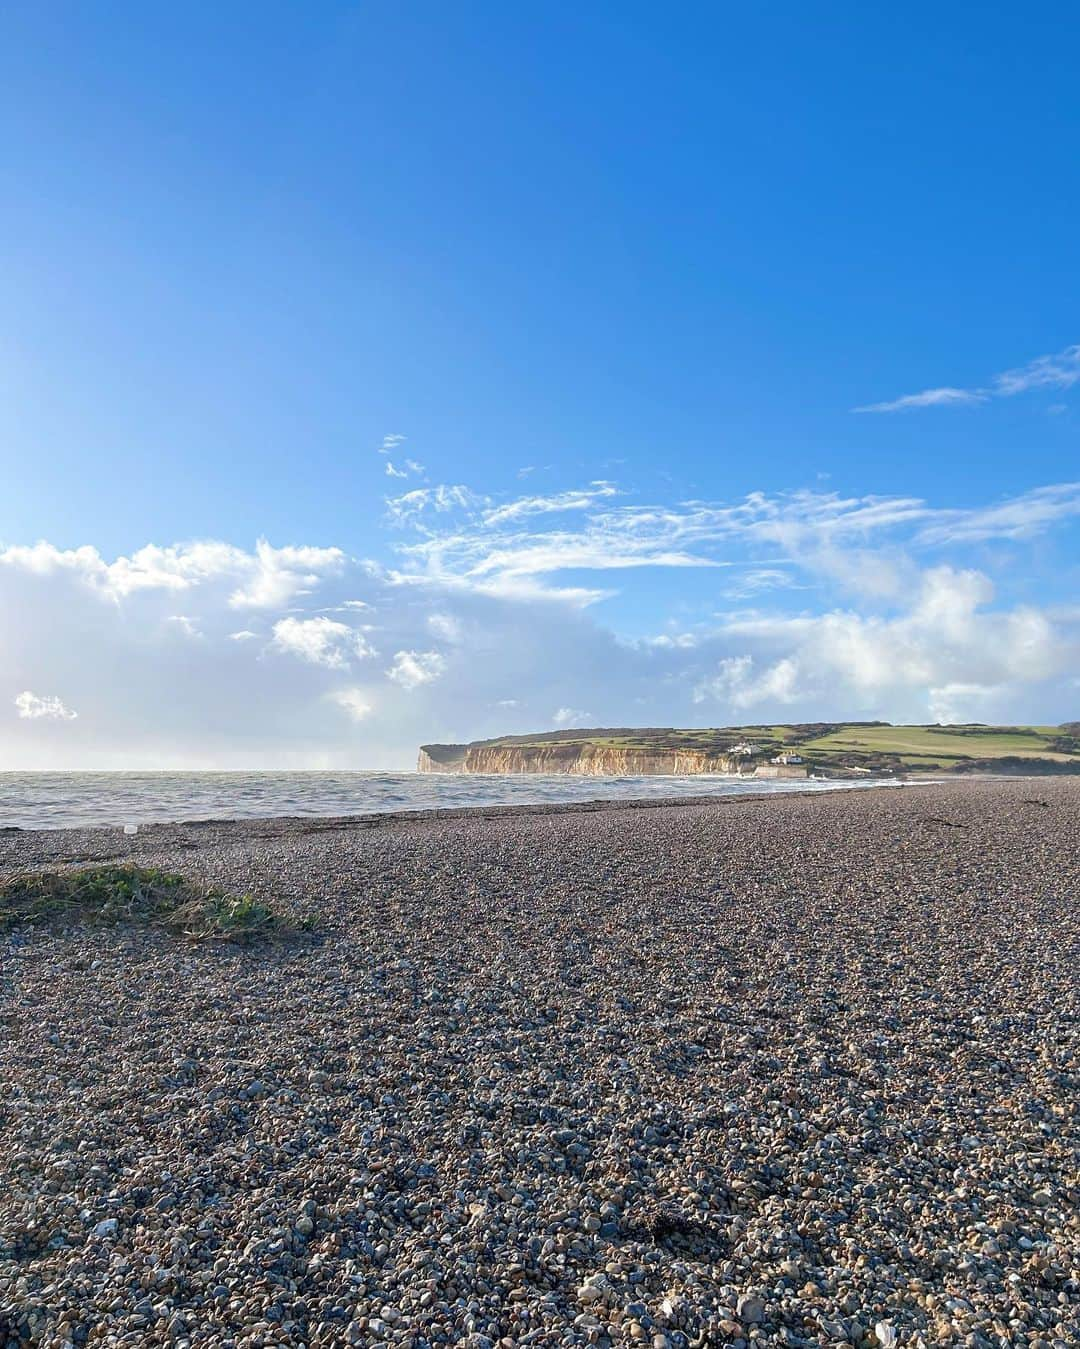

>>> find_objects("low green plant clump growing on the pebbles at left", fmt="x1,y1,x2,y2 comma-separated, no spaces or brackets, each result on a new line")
0,866,306,942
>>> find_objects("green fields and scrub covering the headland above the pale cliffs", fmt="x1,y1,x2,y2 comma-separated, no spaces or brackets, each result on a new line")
458,722,1080,773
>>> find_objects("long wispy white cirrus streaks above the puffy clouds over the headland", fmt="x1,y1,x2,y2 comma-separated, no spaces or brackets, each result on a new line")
377,483,1080,606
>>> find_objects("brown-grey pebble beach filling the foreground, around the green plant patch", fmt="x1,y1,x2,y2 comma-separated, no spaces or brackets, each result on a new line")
0,778,1080,1349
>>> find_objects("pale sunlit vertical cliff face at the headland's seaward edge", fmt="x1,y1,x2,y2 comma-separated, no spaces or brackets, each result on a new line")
417,743,750,777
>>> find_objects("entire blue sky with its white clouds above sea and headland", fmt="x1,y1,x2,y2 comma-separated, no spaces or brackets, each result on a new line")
0,3,1080,766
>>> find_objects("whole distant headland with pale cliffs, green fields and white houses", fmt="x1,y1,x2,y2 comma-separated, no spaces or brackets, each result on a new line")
419,722,1080,776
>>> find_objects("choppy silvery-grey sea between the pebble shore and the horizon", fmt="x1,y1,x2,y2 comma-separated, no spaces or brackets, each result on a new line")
0,772,894,830
